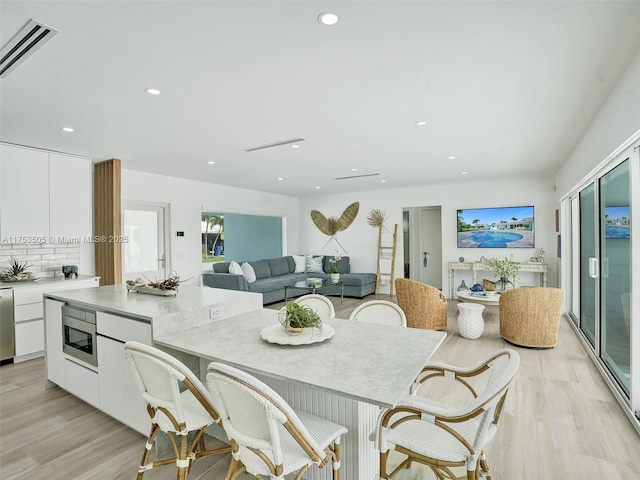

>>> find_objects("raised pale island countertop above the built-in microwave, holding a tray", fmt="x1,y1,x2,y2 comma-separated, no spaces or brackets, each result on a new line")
44,284,262,324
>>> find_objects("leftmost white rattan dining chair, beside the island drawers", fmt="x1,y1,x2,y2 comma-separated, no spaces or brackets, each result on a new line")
124,341,231,480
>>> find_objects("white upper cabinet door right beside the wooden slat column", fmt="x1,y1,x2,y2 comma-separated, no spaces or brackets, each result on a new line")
49,153,93,238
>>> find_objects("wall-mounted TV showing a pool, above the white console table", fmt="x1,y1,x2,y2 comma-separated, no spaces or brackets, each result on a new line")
458,207,535,248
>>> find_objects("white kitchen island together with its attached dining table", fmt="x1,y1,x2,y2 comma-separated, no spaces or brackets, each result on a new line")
45,285,446,480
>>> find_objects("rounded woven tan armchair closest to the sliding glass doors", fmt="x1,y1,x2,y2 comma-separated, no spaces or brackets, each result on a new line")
500,287,564,348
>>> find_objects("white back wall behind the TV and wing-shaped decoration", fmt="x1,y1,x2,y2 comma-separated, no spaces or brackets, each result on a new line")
298,177,557,294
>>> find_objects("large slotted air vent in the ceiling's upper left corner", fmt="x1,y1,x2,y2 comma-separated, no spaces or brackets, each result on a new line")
0,19,58,78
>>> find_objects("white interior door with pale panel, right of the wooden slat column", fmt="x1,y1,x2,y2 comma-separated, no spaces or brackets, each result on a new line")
122,202,169,283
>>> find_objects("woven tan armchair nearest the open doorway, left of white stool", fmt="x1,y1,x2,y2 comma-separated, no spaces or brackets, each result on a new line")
396,278,447,330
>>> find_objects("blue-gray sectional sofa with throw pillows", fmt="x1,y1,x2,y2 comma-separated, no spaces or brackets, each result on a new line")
202,256,376,305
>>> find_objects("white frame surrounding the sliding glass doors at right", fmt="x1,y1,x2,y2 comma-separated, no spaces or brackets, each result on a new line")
560,131,640,432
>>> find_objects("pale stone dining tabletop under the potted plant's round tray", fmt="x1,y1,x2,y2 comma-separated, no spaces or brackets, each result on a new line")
154,309,446,407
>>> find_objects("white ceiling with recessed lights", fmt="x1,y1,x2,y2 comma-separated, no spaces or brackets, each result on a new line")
0,0,640,196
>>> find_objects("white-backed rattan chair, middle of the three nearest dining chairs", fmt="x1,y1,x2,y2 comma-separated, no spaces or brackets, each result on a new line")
207,362,347,480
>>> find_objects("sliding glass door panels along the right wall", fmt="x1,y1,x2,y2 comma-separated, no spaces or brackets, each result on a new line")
571,158,632,398
